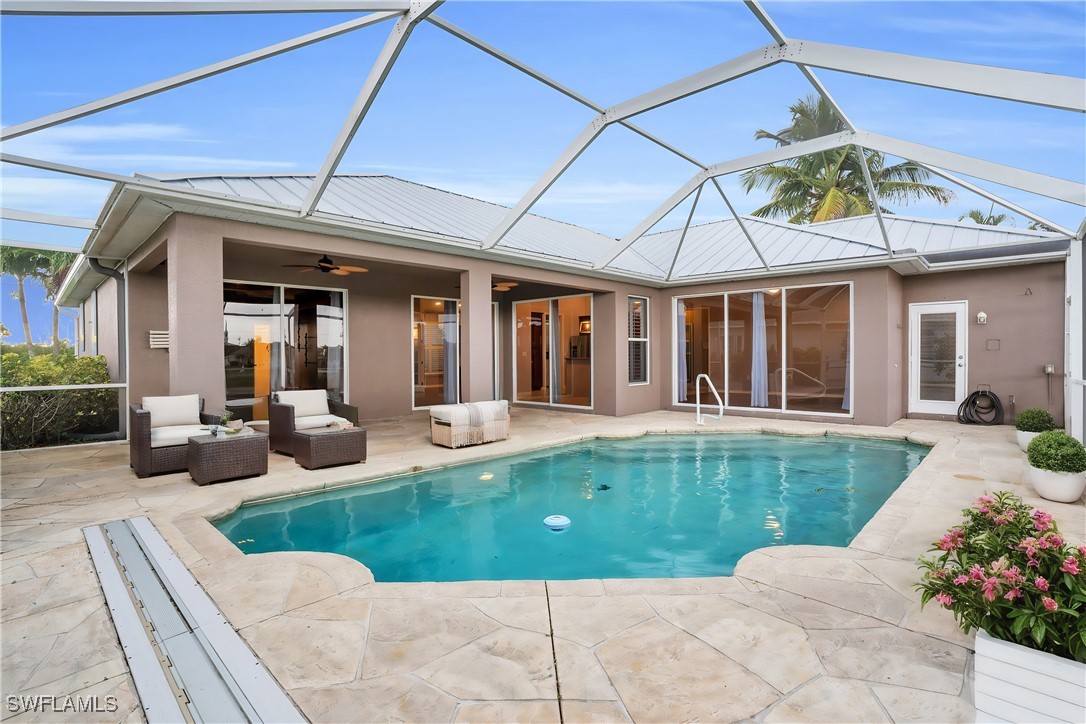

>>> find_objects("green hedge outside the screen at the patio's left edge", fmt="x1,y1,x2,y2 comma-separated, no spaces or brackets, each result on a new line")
0,352,118,449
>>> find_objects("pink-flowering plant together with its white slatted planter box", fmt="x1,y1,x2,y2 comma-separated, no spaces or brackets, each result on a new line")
917,493,1086,722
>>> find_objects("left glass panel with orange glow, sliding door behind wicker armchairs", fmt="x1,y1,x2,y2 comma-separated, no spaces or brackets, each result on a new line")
223,282,281,420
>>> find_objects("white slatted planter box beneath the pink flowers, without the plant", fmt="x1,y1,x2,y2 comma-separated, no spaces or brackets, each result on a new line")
973,631,1086,722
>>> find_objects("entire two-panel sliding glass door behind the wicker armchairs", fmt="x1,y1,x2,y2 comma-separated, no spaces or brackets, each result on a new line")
223,281,346,420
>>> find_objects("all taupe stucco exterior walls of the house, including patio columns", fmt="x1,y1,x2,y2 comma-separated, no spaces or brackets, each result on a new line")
85,214,1064,425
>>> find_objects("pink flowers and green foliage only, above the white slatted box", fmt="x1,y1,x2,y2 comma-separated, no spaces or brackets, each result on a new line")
917,493,1086,662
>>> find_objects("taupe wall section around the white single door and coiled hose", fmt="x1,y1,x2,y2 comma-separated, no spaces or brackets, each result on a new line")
889,262,1065,424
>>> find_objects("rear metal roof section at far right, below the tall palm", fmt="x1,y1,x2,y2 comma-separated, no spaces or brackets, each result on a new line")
809,214,1065,254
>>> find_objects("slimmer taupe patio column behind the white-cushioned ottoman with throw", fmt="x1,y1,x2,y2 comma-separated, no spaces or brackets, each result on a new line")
460,269,494,403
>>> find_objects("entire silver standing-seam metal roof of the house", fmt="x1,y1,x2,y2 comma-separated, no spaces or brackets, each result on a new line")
150,174,1061,281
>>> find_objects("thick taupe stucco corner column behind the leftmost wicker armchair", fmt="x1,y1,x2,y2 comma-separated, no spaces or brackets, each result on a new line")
166,217,226,411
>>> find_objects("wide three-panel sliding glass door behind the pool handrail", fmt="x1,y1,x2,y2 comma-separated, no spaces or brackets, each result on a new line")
674,283,851,415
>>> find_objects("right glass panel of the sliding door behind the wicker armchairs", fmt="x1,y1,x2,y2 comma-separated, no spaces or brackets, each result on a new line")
282,287,343,399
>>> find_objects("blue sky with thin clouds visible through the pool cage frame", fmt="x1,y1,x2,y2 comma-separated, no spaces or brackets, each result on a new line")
0,0,1086,251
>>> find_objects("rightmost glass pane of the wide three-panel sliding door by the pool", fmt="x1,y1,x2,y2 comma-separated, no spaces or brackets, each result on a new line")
782,284,851,412
